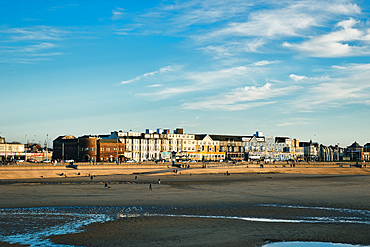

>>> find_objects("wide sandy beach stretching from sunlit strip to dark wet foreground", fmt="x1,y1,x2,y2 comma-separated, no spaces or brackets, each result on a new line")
0,165,370,246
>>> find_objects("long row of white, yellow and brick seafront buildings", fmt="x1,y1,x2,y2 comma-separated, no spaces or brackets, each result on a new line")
23,128,370,162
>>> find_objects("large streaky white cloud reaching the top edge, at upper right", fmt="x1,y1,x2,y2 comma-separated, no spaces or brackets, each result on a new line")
203,1,361,38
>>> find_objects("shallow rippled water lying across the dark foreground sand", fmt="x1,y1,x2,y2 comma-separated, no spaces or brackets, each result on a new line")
0,204,370,247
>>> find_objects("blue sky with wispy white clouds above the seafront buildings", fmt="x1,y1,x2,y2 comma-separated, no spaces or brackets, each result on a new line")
0,0,370,147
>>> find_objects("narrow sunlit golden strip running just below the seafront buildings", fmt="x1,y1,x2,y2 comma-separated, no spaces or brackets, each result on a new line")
0,162,370,180
